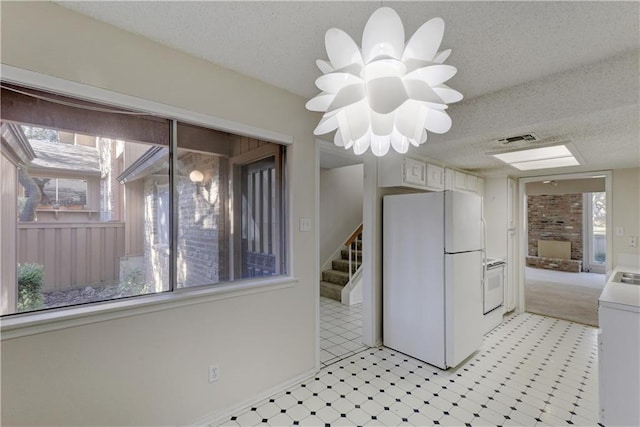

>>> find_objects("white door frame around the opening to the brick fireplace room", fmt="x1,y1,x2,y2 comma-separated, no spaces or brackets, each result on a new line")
516,170,613,313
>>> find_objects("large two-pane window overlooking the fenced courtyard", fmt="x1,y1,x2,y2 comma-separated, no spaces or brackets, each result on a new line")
0,84,286,315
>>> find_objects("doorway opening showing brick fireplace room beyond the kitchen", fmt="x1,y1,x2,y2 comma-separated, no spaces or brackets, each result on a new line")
521,175,608,327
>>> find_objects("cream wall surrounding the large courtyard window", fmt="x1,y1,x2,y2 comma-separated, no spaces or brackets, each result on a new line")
1,2,318,425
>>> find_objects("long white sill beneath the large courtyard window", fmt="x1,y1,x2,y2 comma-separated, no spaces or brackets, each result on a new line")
0,276,298,341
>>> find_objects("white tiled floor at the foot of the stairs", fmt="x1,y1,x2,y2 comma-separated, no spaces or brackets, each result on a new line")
320,297,367,367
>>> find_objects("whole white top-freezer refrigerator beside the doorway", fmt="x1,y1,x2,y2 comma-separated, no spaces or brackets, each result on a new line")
382,191,484,369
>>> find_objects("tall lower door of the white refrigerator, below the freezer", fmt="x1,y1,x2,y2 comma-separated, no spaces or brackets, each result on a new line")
445,251,483,367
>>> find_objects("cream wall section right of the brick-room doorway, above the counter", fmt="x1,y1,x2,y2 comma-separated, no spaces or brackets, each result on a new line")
608,168,640,268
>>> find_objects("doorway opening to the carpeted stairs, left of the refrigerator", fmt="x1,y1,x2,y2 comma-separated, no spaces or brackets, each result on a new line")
317,143,367,367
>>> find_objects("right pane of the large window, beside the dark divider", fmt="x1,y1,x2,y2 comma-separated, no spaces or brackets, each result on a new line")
174,123,285,287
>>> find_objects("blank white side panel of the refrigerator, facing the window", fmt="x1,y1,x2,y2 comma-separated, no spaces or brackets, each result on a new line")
382,193,445,368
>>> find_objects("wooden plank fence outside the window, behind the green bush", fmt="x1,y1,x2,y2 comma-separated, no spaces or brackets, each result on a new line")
17,222,125,291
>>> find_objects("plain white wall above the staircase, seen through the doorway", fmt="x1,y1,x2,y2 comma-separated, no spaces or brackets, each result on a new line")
320,164,364,265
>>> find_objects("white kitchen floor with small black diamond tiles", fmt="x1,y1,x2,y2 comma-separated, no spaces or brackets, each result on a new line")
222,313,598,426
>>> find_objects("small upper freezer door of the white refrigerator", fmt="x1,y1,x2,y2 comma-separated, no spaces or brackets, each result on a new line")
444,191,484,253
